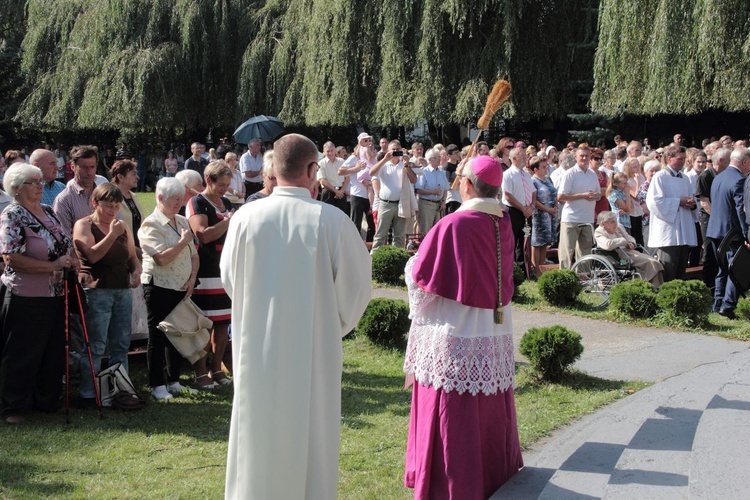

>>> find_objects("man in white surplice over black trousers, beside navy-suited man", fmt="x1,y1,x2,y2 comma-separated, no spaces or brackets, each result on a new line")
646,145,710,282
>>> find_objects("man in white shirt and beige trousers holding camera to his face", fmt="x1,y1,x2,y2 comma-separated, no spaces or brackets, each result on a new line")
370,140,417,251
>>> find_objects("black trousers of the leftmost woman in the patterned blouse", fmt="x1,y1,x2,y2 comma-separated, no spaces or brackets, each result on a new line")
0,291,66,417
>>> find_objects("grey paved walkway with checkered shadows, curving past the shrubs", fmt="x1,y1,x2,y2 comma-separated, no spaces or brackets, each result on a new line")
374,289,750,499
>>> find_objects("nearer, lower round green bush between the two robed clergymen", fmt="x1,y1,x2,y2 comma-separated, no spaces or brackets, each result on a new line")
357,297,411,349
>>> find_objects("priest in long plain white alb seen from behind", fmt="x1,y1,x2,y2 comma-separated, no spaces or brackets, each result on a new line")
221,134,372,499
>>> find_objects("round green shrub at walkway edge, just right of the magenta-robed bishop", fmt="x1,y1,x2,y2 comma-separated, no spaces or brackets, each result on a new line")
521,324,583,381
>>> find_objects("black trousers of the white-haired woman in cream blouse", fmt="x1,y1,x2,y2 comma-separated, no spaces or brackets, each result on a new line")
143,284,185,387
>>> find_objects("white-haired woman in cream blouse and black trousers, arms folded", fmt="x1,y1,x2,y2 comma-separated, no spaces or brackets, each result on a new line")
138,177,216,400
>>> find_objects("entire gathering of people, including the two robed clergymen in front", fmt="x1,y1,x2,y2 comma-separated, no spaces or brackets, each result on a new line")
0,132,750,498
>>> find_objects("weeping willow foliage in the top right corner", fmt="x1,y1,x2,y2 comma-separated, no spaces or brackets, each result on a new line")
591,0,750,116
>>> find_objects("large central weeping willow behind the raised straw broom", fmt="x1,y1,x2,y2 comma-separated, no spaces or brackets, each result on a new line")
238,0,582,126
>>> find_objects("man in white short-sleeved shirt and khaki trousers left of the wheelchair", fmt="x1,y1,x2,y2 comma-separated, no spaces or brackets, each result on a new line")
557,146,602,269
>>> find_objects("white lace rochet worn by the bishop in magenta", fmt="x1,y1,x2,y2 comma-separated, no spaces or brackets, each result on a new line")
404,257,515,395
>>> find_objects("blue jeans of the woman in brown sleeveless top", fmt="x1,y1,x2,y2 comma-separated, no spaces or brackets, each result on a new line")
80,288,133,398
